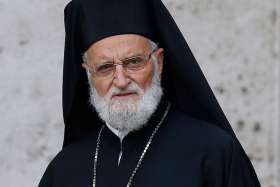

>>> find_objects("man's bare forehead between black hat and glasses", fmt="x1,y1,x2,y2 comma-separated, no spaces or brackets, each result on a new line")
87,34,150,58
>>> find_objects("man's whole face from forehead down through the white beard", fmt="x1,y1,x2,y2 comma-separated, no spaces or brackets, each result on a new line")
83,35,163,134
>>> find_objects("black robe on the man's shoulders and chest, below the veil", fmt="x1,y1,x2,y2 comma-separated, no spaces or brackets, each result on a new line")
39,98,258,187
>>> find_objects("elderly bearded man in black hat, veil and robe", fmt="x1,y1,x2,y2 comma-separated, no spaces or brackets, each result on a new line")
39,0,260,187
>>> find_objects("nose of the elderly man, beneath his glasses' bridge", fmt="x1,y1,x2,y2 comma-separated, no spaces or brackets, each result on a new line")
113,65,130,89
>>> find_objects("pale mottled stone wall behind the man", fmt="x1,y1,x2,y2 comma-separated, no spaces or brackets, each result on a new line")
0,0,280,187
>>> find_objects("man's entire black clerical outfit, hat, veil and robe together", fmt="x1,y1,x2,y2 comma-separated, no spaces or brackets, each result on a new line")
39,0,260,187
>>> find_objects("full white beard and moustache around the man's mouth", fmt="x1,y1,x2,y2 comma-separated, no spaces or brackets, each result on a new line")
89,62,163,136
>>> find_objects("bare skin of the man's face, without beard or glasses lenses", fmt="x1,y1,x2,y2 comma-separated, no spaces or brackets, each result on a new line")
83,34,163,100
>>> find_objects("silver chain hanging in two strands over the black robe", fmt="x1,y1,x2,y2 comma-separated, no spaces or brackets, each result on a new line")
92,103,171,187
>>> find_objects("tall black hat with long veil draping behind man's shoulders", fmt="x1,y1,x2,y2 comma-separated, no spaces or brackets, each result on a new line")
63,0,260,183
